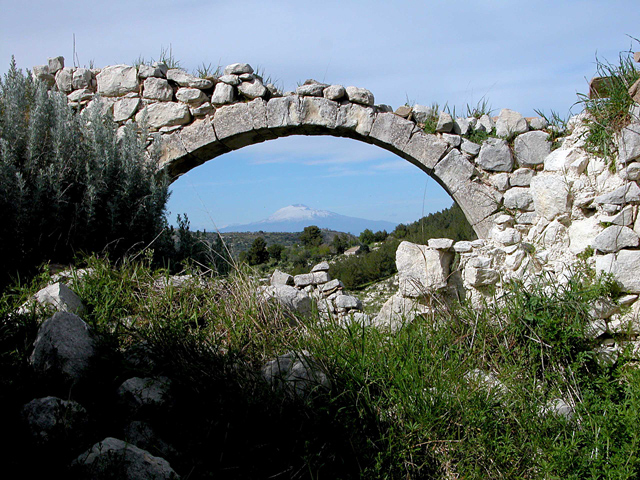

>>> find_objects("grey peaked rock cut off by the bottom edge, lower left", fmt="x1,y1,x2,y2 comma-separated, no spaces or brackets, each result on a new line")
72,437,180,480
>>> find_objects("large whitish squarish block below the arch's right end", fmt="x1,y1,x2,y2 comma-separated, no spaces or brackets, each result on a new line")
396,241,453,297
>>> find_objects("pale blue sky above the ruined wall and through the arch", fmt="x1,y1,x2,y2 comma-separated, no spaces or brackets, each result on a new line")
0,0,640,230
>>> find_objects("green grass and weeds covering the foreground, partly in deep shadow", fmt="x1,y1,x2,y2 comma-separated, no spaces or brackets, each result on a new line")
0,253,640,480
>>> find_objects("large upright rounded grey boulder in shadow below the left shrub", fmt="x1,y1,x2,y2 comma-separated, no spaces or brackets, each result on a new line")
29,312,95,383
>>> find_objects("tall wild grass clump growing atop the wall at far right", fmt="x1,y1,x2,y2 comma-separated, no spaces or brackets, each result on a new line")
577,39,640,158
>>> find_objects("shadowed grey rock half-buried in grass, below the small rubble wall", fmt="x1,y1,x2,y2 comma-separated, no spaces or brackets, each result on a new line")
262,351,331,398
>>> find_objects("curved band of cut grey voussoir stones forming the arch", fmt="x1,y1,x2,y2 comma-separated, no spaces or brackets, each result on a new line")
148,95,502,238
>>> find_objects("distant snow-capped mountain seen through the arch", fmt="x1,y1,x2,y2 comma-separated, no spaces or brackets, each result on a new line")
220,204,396,235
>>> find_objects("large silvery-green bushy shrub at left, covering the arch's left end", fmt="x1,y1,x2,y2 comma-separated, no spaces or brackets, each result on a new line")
0,59,169,285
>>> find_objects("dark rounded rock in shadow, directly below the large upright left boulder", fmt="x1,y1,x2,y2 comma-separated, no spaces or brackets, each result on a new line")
22,397,89,450
